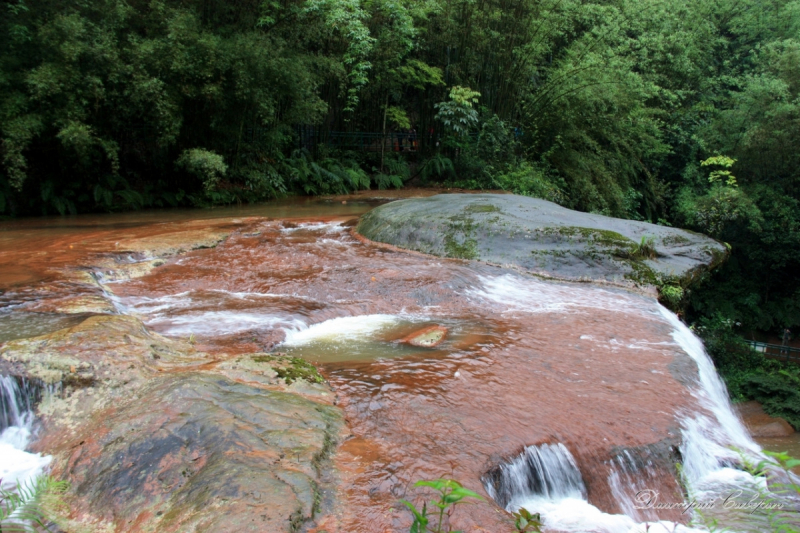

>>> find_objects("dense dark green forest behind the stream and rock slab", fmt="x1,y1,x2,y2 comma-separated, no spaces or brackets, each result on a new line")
0,0,800,420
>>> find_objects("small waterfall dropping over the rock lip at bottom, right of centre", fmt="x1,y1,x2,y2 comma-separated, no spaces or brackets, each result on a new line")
483,443,586,511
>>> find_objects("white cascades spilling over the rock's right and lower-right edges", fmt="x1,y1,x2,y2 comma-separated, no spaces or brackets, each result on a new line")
482,306,780,533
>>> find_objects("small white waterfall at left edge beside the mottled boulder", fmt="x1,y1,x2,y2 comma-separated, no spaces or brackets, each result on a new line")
0,376,51,489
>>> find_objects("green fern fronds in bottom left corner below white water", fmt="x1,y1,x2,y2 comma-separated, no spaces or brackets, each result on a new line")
0,476,69,532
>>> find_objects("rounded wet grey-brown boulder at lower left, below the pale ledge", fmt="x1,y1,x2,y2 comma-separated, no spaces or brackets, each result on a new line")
47,373,343,532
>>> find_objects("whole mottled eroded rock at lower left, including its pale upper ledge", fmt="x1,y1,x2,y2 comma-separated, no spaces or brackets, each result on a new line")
0,315,344,532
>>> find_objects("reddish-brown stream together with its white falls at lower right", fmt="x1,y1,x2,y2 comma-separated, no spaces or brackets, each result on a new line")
0,197,792,533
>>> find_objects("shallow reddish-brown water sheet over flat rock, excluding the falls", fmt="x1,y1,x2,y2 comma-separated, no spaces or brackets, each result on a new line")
0,197,720,533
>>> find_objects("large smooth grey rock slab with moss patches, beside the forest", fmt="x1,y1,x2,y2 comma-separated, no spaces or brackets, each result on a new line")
358,194,728,285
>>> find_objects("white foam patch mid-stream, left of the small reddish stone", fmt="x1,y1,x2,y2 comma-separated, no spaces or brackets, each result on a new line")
283,315,402,346
